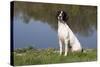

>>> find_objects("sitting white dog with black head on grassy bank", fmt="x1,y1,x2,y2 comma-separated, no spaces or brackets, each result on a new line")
57,11,82,56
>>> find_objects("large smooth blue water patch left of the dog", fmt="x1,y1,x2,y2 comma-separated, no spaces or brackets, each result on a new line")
14,18,58,48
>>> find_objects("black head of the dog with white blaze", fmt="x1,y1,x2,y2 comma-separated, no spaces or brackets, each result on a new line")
57,10,68,21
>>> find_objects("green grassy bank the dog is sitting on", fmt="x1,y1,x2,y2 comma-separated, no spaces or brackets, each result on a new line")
13,48,97,66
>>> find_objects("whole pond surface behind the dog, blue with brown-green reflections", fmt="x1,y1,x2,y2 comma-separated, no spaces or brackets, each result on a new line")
13,2,97,48
